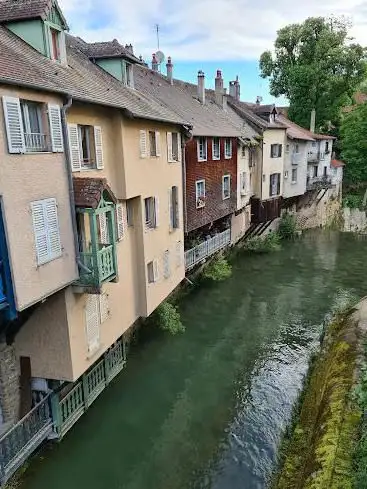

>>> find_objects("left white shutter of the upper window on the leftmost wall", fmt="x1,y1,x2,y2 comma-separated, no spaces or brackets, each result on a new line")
3,97,25,153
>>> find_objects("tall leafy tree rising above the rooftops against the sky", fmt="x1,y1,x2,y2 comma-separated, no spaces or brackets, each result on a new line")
260,17,366,129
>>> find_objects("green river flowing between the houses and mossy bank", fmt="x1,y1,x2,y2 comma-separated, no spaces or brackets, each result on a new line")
22,231,367,489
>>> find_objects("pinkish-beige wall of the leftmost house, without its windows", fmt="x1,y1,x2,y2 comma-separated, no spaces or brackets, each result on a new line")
0,86,78,310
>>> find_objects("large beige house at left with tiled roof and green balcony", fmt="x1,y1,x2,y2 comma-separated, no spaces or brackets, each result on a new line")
0,15,189,381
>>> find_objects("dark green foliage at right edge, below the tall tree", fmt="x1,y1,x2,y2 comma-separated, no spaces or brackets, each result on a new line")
340,103,367,183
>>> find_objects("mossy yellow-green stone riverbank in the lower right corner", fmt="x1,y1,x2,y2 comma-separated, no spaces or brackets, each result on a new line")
273,298,367,489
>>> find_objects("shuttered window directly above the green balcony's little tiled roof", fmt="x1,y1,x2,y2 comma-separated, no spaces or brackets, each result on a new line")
68,124,104,171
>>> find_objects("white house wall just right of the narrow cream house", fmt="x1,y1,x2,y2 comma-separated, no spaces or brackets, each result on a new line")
283,138,308,198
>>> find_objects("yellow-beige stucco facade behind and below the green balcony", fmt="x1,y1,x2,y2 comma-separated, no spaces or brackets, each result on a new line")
16,104,185,381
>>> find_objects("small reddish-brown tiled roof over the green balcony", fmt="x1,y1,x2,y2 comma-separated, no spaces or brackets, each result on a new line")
73,177,117,209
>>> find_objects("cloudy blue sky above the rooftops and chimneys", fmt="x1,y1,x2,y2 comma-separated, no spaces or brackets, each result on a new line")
59,0,367,105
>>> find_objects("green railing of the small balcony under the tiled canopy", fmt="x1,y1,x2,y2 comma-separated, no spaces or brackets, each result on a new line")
80,244,116,287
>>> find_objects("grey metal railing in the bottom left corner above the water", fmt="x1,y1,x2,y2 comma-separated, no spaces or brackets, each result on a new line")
0,394,53,484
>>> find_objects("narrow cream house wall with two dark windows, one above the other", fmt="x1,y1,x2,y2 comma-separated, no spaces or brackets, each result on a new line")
261,129,286,200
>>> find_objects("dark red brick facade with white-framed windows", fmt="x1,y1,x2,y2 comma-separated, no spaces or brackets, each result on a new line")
185,137,237,232
